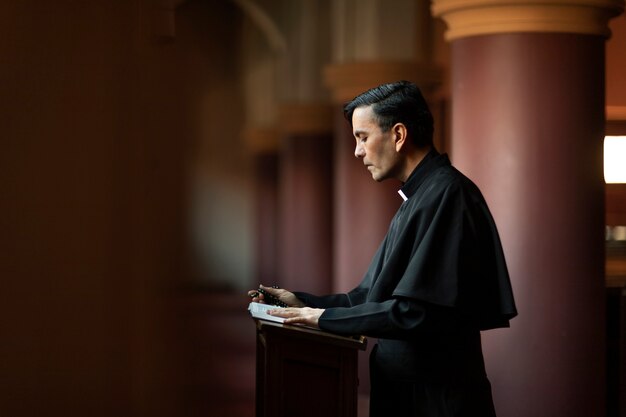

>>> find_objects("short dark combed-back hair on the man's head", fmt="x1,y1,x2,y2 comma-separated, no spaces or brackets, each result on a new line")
343,81,433,147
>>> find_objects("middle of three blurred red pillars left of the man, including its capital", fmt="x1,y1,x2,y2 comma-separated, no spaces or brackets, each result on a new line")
279,104,333,294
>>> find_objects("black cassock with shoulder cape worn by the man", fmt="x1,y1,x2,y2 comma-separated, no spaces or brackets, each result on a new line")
296,150,517,417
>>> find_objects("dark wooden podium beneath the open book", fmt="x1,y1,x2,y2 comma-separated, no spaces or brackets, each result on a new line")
254,319,366,417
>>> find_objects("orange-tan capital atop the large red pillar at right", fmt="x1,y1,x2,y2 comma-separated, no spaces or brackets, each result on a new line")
431,0,624,41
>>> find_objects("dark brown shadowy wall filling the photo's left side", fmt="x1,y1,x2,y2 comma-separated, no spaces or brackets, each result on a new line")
0,0,240,416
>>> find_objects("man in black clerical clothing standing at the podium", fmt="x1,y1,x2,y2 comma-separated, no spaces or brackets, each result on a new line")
250,81,517,417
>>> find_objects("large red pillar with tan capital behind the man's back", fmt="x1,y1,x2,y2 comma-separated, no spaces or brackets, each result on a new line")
433,0,619,417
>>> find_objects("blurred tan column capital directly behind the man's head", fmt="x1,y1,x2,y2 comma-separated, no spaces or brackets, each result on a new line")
324,61,443,104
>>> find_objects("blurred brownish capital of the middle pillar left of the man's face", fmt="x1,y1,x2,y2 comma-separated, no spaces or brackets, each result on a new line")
278,103,333,134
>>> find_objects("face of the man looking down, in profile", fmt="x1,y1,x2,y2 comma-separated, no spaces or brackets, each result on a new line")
352,106,400,181
